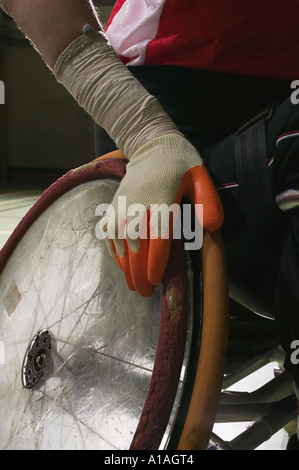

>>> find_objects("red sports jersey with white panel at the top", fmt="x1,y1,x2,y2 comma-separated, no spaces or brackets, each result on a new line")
106,0,299,80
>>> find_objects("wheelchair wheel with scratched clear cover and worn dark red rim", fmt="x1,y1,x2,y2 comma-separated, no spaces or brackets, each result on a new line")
0,158,229,450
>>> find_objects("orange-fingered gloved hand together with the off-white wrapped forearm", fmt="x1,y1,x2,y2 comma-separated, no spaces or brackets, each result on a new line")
54,25,223,296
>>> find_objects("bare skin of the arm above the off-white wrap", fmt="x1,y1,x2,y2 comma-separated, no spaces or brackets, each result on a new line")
0,0,101,68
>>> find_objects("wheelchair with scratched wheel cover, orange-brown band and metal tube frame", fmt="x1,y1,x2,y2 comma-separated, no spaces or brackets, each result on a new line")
0,151,297,451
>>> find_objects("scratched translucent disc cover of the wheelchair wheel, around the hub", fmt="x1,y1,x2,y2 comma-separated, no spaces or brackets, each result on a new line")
0,180,169,449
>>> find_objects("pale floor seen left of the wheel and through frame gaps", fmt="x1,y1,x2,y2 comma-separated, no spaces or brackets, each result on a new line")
0,184,296,450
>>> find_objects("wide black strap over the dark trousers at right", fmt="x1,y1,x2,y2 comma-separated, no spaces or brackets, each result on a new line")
235,109,281,229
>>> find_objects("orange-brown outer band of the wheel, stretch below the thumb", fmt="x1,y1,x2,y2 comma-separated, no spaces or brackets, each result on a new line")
178,232,229,450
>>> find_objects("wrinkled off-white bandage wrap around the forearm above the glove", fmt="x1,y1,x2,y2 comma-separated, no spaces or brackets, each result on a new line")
53,28,180,159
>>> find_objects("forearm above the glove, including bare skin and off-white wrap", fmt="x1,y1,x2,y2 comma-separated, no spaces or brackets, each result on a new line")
0,0,178,158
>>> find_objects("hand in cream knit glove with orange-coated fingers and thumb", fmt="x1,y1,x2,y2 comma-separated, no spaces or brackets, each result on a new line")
101,133,223,297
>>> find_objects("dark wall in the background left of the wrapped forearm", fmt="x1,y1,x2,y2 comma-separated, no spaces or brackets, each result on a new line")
1,6,111,174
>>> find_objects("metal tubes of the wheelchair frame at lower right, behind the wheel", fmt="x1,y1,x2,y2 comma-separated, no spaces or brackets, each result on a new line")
210,346,298,450
